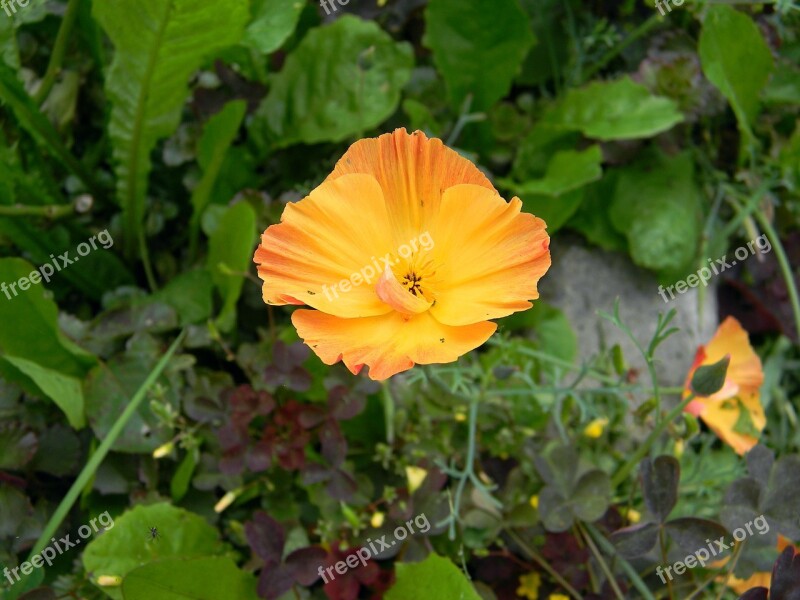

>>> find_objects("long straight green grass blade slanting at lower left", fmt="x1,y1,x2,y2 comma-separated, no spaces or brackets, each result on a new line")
23,330,186,561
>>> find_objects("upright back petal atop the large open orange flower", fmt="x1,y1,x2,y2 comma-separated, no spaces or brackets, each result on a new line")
328,129,494,248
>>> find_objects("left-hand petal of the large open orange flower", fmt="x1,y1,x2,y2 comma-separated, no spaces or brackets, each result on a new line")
253,175,393,317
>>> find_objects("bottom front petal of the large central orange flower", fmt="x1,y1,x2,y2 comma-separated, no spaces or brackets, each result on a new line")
292,309,497,380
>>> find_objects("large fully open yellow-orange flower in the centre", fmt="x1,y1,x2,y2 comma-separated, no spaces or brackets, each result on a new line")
254,129,550,380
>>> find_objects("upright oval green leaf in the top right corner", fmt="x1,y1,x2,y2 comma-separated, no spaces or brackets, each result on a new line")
698,5,773,138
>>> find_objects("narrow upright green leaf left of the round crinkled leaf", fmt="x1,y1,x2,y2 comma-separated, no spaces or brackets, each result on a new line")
189,100,247,255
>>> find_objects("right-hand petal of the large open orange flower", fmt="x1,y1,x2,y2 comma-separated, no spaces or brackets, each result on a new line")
430,184,550,325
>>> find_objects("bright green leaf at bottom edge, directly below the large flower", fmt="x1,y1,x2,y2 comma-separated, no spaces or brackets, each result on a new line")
385,554,480,600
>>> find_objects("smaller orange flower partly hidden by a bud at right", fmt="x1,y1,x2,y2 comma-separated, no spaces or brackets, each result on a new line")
684,317,767,454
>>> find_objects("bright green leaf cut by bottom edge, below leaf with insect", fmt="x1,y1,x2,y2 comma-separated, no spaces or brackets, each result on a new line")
122,557,258,600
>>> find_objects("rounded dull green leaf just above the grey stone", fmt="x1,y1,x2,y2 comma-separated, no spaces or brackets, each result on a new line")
610,152,701,273
